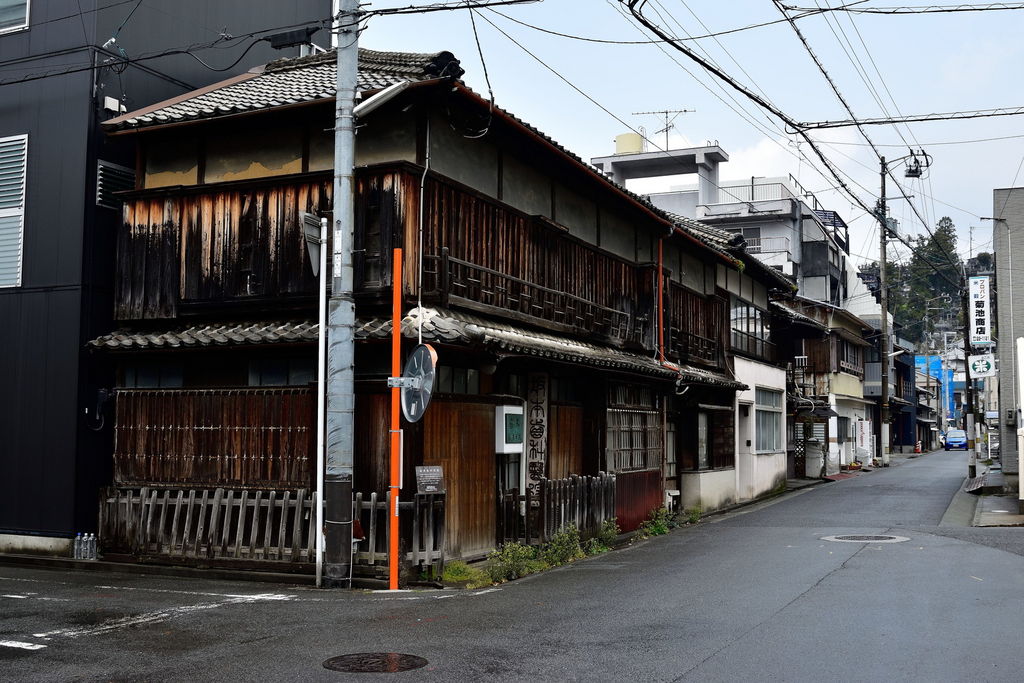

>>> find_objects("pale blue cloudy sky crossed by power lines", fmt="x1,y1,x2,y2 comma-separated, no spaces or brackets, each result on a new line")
359,0,1024,261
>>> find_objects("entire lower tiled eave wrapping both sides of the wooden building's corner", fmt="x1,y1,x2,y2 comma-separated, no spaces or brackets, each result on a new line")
88,308,743,389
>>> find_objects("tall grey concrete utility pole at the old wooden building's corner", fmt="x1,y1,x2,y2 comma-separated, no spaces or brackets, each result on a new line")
321,0,359,588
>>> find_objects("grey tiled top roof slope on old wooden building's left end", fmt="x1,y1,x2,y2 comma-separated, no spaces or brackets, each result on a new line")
103,49,463,130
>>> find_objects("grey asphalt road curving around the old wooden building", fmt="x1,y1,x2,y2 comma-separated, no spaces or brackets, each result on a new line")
0,452,1024,681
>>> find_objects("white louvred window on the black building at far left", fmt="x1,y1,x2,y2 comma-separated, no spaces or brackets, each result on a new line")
0,135,29,287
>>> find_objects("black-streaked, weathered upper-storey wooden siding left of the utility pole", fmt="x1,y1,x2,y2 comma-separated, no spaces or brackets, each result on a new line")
115,178,331,319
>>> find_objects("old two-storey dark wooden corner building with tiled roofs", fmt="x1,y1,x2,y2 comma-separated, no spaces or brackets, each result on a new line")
91,45,784,569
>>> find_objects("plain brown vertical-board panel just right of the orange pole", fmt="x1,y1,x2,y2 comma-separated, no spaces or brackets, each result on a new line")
423,400,498,557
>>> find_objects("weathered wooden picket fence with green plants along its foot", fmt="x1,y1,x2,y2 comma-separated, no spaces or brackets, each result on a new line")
498,472,615,545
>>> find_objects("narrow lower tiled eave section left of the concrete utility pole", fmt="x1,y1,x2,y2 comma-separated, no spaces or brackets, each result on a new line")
86,321,317,350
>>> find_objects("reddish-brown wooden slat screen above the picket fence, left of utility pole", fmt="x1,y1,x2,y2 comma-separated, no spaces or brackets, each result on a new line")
114,387,316,489
